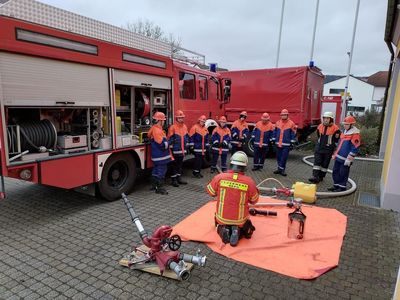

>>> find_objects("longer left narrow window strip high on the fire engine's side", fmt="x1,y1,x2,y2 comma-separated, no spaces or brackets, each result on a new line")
16,28,97,55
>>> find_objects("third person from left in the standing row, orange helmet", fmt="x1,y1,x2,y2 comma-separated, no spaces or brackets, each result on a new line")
189,115,210,178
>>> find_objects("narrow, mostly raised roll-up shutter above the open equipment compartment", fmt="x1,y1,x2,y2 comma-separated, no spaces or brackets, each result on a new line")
114,70,171,90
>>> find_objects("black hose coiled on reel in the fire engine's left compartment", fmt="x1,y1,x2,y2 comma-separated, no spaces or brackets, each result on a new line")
8,119,57,152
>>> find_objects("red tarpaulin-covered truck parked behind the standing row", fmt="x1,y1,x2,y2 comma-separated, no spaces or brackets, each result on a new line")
221,66,324,155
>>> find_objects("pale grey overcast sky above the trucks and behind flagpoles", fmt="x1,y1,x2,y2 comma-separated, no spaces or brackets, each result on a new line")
41,0,390,76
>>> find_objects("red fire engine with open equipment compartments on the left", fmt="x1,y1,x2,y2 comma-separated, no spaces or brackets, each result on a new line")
0,0,229,200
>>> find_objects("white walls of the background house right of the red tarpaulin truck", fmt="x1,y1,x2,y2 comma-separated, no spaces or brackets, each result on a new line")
324,76,376,109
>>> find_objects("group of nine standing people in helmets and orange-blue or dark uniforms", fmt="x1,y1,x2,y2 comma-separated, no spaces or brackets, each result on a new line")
148,109,360,194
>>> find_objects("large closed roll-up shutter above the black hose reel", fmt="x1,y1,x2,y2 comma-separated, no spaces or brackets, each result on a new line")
0,52,110,106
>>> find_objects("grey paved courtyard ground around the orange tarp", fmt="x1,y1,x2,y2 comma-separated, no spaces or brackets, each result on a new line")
0,152,400,300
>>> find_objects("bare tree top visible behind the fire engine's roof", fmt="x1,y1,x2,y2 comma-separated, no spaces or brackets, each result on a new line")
122,19,182,53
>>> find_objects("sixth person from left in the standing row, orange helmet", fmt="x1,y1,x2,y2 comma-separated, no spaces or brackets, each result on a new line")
251,113,275,171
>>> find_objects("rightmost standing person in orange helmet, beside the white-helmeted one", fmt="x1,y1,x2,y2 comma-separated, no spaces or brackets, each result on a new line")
328,116,361,192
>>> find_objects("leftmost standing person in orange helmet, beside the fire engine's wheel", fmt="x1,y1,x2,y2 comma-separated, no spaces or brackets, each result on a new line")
147,112,172,195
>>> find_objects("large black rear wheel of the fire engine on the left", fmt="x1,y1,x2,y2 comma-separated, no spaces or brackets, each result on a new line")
98,153,137,201
